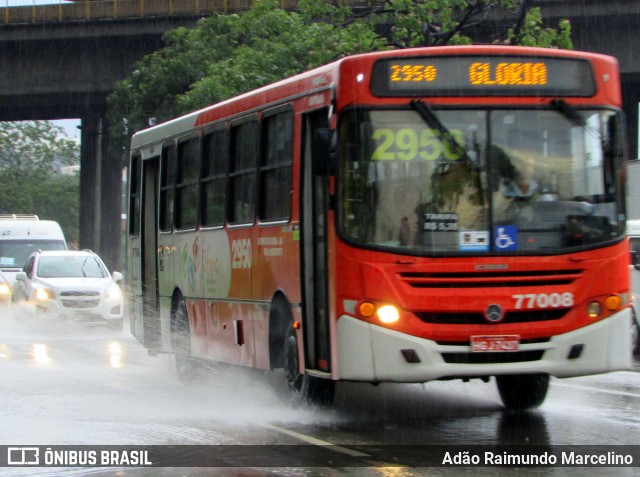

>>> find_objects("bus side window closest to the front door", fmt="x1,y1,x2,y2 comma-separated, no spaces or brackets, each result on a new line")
259,111,293,221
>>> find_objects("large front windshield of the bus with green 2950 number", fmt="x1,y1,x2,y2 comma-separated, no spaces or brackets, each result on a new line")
338,106,624,255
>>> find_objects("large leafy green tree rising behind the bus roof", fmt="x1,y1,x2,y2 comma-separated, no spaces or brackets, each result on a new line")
108,0,572,148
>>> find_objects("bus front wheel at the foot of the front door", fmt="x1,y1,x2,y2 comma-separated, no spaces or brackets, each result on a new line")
284,328,335,405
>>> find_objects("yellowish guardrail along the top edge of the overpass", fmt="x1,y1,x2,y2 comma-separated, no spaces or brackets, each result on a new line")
0,0,310,25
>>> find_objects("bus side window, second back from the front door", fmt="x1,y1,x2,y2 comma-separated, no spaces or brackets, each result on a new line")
228,120,258,224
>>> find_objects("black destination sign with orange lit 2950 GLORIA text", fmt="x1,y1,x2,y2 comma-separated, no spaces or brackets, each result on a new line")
371,56,595,97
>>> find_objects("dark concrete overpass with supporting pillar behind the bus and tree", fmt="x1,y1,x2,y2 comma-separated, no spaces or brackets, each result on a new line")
0,0,640,268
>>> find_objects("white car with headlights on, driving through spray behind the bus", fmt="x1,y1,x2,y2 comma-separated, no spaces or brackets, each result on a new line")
13,250,124,328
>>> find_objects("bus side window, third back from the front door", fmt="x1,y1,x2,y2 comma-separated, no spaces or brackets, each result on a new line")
200,129,229,227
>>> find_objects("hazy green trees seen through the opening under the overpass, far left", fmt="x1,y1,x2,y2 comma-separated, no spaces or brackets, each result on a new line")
0,121,80,242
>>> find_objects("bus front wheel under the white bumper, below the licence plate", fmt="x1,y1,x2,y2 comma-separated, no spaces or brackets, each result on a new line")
496,374,549,411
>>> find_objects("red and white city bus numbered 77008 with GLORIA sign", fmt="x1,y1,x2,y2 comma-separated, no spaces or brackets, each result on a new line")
128,46,631,408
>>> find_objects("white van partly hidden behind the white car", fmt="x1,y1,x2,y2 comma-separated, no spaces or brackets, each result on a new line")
0,214,67,286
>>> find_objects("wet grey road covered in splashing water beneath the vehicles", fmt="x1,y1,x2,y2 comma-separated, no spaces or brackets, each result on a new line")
0,304,640,477
